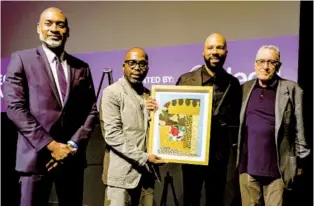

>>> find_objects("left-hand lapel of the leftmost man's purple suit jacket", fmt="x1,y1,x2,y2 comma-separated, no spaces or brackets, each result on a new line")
37,46,62,106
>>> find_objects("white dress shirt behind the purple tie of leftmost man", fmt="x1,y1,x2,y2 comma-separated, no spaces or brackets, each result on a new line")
42,45,69,105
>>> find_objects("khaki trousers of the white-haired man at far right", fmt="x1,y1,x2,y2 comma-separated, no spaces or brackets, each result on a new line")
240,173,285,206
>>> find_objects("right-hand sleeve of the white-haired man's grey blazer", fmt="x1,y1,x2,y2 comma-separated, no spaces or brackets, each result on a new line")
294,86,310,159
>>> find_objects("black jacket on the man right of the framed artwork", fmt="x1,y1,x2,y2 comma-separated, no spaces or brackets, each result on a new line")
177,65,241,161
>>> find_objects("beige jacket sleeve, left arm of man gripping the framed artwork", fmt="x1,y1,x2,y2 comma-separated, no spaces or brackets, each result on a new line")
100,88,148,166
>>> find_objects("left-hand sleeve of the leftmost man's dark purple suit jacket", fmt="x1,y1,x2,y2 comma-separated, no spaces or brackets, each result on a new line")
4,53,53,151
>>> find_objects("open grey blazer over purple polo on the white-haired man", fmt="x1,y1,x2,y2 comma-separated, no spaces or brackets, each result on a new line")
237,78,310,189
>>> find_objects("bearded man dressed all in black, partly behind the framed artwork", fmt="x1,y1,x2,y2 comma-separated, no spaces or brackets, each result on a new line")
177,33,241,206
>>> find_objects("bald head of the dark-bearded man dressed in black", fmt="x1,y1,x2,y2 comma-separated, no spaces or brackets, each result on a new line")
203,33,228,69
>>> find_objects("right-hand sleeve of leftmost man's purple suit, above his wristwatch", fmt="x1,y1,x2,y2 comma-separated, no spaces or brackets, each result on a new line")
71,67,98,144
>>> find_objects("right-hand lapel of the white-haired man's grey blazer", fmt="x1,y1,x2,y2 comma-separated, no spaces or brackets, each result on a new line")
275,79,289,143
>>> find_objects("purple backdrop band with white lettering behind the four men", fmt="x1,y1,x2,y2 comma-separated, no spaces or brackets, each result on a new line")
0,36,299,112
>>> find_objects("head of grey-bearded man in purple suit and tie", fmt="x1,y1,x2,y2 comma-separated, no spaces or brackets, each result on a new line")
37,7,69,50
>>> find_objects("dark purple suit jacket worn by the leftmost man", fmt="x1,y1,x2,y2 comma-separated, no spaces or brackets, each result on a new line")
4,46,98,172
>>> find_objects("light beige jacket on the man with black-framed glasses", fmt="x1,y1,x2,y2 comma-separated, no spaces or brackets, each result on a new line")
100,78,157,189
